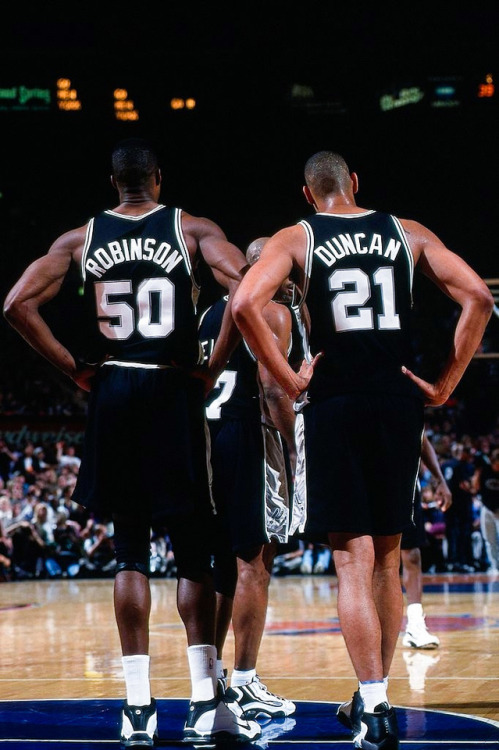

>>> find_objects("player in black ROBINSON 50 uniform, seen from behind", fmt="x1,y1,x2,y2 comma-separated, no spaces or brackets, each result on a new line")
4,139,260,747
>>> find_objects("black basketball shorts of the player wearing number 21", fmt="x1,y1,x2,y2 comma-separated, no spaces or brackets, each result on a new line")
294,394,424,540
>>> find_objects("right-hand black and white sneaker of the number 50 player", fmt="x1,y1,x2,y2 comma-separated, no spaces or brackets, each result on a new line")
183,697,262,745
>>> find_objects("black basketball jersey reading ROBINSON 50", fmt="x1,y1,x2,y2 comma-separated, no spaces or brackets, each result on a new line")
81,205,201,367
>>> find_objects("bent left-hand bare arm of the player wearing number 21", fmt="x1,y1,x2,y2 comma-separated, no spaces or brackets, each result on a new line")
232,226,316,400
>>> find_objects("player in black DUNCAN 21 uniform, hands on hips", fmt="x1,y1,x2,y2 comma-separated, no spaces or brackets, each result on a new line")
233,151,493,750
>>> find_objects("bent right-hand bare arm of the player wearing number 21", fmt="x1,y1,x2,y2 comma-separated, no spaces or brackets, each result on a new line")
402,220,494,406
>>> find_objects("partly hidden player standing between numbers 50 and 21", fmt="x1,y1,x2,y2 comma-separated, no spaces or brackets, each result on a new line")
199,238,303,718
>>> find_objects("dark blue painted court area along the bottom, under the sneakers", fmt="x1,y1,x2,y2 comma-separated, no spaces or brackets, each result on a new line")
0,698,499,750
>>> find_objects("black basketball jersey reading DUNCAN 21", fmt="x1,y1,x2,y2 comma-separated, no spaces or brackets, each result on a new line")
299,211,420,400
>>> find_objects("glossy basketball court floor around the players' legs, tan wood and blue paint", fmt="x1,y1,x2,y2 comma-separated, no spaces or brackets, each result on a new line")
0,573,499,750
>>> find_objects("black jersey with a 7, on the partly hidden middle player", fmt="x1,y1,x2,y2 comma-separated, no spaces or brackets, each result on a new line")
199,297,261,421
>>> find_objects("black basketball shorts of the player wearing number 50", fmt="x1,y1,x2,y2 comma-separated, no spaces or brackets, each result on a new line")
73,365,211,520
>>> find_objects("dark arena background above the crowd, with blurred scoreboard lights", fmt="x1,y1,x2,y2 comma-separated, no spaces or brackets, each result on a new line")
0,2,499,431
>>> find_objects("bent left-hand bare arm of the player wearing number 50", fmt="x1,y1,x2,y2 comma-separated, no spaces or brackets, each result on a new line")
3,227,95,390
